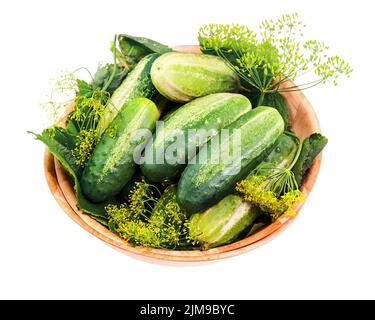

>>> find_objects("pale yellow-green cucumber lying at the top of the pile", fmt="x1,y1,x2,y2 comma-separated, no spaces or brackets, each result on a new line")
151,52,240,102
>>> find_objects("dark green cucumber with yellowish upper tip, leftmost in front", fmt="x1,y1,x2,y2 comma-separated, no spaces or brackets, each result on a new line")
81,98,159,202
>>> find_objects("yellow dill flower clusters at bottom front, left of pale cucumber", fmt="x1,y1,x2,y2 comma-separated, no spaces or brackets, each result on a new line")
106,179,194,249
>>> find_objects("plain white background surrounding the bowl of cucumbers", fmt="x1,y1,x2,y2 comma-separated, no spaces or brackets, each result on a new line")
0,0,375,299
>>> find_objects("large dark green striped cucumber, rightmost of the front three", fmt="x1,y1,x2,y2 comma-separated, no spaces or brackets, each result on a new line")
177,107,284,213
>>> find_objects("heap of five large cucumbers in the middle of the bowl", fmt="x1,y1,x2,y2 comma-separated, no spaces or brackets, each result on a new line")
81,52,284,209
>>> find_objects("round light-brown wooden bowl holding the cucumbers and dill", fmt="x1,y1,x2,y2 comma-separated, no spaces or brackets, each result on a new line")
44,46,321,264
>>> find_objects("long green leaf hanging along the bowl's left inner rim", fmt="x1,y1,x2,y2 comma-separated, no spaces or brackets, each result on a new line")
30,127,108,225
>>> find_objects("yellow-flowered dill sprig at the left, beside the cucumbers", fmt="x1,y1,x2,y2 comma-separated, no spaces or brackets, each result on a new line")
43,36,123,167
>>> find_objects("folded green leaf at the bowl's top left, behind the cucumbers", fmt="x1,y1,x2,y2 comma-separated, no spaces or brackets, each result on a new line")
118,34,172,68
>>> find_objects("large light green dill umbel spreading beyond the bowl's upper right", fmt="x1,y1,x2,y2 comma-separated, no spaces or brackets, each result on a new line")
198,13,353,103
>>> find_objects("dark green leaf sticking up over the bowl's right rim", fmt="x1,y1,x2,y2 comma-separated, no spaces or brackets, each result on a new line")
293,133,328,186
